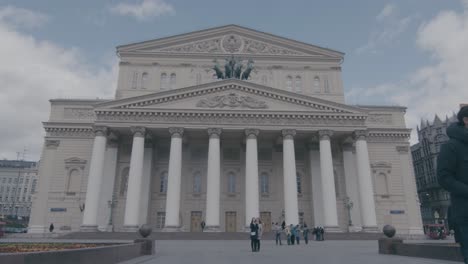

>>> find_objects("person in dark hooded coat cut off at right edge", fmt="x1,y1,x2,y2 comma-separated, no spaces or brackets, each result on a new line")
437,106,468,264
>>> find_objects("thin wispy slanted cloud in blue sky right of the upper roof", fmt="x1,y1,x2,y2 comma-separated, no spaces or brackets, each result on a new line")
356,4,416,54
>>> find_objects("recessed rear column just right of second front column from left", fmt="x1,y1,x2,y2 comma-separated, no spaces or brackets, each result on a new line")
140,144,153,225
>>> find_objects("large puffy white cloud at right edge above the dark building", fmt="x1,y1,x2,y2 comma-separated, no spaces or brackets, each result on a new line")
349,0,468,142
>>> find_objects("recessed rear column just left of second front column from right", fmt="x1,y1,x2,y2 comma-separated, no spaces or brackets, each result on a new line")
309,142,324,226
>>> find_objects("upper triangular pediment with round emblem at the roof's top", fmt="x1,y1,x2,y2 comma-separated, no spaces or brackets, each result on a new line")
117,25,344,59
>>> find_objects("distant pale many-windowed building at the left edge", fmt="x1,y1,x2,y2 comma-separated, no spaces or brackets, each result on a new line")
0,160,38,220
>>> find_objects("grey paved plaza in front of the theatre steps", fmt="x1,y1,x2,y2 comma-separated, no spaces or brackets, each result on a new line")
119,240,460,264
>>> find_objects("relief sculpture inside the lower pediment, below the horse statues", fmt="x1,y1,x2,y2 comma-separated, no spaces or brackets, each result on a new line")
197,93,268,109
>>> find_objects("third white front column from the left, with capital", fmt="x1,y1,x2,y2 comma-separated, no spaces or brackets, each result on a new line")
163,127,184,231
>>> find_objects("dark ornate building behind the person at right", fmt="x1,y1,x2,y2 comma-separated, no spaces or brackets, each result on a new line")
411,115,457,224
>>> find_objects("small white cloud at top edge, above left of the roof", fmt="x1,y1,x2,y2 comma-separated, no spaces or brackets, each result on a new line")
110,0,175,20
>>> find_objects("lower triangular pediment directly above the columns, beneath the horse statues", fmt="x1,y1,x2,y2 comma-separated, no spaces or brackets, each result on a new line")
96,79,366,115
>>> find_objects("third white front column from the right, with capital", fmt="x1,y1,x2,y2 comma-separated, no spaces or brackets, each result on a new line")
282,129,299,225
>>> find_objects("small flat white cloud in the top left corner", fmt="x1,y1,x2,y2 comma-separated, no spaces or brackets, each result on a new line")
0,6,48,29
